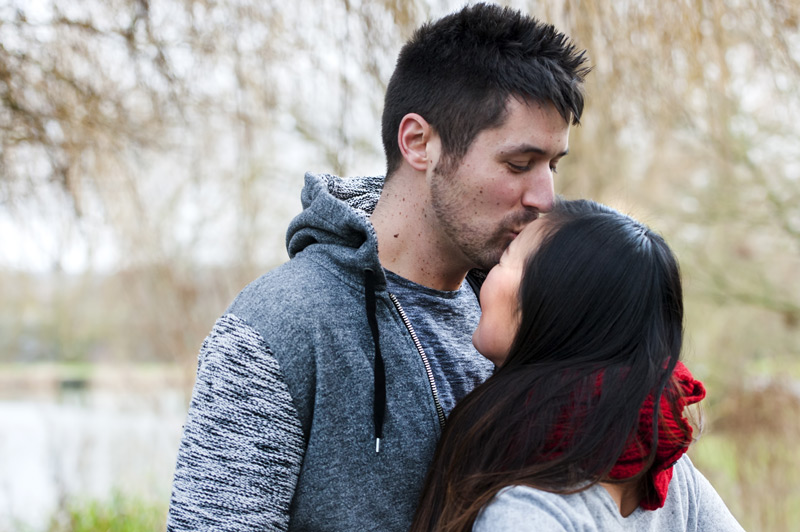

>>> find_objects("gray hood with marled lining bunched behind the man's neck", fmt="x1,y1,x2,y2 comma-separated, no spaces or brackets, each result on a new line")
286,173,385,285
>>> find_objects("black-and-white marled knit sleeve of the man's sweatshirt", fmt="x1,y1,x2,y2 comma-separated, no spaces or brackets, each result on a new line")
167,314,304,532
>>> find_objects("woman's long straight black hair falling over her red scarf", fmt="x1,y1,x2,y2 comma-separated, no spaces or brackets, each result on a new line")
411,200,683,531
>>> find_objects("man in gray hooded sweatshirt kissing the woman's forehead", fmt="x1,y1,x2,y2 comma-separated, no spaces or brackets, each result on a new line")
168,4,588,531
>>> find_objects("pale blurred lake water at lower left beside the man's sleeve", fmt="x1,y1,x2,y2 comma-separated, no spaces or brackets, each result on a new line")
0,380,186,532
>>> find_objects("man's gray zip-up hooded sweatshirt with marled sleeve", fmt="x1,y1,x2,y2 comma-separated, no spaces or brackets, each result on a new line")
167,174,485,531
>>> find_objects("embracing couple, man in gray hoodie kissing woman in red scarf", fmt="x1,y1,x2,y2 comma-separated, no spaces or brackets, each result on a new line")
167,4,741,531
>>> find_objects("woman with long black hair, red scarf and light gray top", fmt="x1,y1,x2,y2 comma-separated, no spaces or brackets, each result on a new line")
412,200,741,532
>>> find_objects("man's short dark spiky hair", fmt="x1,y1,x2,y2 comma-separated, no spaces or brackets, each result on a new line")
382,3,590,176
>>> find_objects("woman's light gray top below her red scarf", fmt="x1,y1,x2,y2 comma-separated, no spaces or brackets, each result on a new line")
472,455,742,532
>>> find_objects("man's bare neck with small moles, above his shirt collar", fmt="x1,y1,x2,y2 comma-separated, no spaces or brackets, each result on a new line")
371,170,470,290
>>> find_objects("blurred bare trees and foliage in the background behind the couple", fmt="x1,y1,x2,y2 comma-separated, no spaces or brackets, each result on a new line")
0,0,800,531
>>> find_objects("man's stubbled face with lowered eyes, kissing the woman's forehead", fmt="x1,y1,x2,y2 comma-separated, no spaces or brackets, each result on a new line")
428,98,569,270
